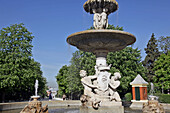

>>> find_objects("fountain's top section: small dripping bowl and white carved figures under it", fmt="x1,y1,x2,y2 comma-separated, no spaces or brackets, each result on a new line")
84,0,118,29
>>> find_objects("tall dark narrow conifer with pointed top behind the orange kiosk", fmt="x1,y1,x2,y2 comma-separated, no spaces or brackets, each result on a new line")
142,33,159,82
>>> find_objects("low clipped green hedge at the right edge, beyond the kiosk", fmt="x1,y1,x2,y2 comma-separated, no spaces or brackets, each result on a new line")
155,94,170,103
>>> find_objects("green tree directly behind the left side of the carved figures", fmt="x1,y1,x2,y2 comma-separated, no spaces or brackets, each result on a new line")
56,51,95,99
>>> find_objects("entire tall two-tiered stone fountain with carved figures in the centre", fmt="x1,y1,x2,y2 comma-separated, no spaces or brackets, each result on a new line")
67,0,136,113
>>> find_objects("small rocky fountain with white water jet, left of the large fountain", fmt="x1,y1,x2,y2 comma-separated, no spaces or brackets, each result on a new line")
20,80,48,113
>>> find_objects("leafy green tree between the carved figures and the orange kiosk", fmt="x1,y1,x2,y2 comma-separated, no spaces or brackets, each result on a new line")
107,47,146,96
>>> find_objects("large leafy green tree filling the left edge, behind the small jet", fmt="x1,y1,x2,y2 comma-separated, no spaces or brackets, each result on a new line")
0,23,46,101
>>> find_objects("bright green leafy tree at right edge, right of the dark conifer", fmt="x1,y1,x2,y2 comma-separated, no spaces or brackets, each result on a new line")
153,52,170,92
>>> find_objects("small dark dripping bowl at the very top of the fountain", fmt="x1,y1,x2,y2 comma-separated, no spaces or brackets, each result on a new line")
83,0,118,14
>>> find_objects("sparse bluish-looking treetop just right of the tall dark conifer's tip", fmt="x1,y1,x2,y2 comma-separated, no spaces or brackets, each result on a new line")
158,36,170,54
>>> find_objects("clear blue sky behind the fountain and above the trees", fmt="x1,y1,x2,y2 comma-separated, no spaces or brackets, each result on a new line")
0,0,170,87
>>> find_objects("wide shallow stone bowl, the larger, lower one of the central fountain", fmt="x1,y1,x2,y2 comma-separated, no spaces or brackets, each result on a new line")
67,29,136,53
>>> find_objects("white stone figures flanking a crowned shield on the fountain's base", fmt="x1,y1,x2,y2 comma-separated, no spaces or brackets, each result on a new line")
80,65,121,109
